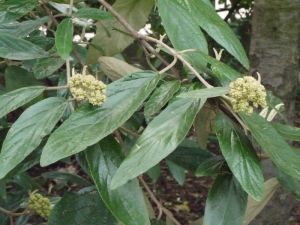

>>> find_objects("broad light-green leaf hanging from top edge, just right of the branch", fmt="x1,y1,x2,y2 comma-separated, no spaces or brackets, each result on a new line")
157,0,208,65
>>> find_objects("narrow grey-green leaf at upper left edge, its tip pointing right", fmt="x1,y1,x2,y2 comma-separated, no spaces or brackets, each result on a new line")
0,16,50,38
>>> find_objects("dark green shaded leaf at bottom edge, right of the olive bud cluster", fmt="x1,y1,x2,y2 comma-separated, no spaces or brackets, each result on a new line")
47,192,118,225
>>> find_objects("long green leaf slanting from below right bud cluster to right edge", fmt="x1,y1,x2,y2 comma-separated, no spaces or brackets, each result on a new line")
239,112,300,180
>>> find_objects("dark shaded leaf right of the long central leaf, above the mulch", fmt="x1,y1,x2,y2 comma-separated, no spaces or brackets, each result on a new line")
167,139,213,172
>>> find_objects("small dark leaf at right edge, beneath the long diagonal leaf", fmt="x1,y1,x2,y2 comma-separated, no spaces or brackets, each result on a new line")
274,165,300,201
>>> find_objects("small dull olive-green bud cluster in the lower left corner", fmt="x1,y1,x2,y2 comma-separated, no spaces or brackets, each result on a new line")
28,193,51,217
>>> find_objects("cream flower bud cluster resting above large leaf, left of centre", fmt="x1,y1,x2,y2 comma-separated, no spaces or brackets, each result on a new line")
68,71,106,106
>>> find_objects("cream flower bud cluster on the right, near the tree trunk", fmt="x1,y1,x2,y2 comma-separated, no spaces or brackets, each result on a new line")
229,76,267,115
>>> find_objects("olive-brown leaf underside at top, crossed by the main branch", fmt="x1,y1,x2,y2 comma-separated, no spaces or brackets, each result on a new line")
86,0,155,65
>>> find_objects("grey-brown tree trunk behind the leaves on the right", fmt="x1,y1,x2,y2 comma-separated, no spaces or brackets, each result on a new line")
249,0,300,225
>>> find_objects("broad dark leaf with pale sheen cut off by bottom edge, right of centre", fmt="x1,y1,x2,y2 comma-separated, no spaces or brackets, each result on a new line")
203,174,247,225
